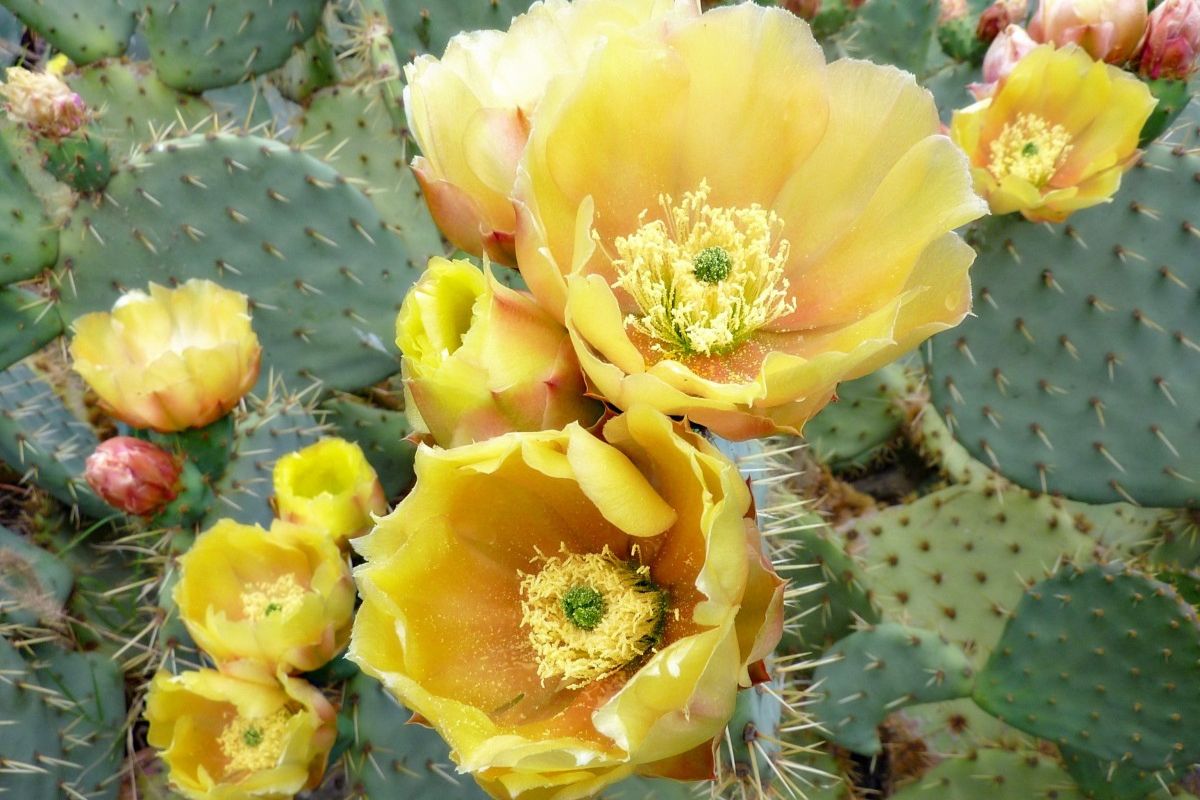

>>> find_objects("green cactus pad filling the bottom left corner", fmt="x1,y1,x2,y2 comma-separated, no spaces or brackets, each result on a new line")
0,638,125,800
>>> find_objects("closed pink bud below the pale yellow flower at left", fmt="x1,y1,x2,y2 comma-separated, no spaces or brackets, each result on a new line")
84,437,180,517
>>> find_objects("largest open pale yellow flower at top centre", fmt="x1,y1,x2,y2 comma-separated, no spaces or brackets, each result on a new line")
517,4,985,439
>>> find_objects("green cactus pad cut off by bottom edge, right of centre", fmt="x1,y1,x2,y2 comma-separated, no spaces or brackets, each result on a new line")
892,750,1084,800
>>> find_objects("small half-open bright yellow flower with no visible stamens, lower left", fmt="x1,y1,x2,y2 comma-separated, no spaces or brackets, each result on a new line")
275,437,388,542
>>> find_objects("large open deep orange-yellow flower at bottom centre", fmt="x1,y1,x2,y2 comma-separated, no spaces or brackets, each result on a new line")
349,407,782,800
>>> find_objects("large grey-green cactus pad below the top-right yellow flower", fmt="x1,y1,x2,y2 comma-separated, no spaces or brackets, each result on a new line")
929,131,1200,506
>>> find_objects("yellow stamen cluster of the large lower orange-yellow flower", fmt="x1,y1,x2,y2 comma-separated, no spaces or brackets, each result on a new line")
521,547,667,688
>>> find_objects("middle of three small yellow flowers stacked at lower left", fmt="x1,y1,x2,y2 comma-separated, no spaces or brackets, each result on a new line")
174,519,354,676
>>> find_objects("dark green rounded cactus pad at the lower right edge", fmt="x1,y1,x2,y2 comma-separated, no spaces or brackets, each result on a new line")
974,565,1200,770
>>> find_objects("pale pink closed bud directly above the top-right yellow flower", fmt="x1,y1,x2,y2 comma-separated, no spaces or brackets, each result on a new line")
1030,0,1146,64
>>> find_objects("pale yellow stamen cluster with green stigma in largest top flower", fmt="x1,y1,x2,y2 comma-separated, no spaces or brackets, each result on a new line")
613,181,796,356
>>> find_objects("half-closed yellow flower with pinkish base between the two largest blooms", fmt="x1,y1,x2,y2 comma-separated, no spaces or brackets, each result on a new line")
396,258,604,447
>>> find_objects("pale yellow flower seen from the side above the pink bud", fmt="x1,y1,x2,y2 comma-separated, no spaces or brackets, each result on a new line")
71,279,262,433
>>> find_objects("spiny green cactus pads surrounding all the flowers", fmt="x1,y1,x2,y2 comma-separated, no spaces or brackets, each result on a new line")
0,0,1200,800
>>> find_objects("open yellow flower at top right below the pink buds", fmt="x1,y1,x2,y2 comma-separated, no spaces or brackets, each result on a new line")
950,46,1156,222
